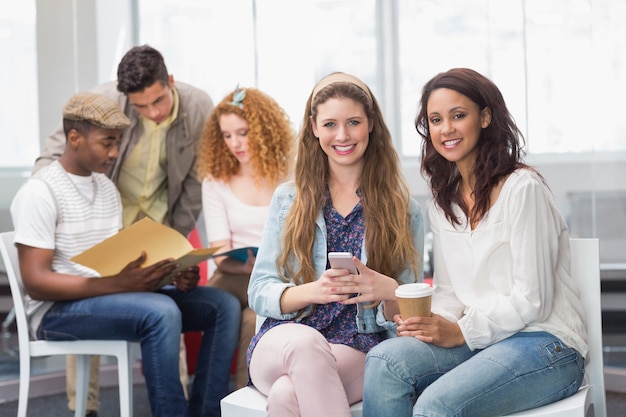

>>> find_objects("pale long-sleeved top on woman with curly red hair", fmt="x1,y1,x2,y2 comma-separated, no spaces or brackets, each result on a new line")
202,178,269,249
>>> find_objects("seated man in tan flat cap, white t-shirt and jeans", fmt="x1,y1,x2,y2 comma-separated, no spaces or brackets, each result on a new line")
11,93,241,417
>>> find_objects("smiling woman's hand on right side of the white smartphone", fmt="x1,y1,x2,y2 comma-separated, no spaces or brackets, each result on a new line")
343,256,398,304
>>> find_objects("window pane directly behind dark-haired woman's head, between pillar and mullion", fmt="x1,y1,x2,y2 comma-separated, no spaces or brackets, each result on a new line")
398,0,526,156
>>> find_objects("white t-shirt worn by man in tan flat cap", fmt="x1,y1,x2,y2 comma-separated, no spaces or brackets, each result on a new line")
11,161,122,337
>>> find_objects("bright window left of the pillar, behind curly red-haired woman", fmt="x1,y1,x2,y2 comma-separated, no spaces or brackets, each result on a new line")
139,0,377,134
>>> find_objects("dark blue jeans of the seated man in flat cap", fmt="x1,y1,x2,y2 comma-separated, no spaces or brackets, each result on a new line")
37,285,241,417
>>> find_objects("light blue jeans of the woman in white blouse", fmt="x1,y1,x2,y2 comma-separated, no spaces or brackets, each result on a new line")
363,332,585,417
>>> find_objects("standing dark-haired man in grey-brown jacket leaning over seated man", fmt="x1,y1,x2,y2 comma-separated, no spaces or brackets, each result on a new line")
33,45,213,417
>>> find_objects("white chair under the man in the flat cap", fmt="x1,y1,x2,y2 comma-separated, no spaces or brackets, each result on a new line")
0,232,138,417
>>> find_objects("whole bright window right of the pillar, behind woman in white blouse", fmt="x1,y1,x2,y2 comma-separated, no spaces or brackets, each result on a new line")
398,0,626,155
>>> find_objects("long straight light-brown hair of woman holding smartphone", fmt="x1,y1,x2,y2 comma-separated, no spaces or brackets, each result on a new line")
276,74,420,285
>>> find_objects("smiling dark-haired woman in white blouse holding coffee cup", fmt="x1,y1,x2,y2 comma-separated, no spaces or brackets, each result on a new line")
363,68,588,417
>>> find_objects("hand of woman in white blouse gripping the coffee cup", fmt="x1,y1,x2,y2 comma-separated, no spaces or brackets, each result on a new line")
393,313,465,348
